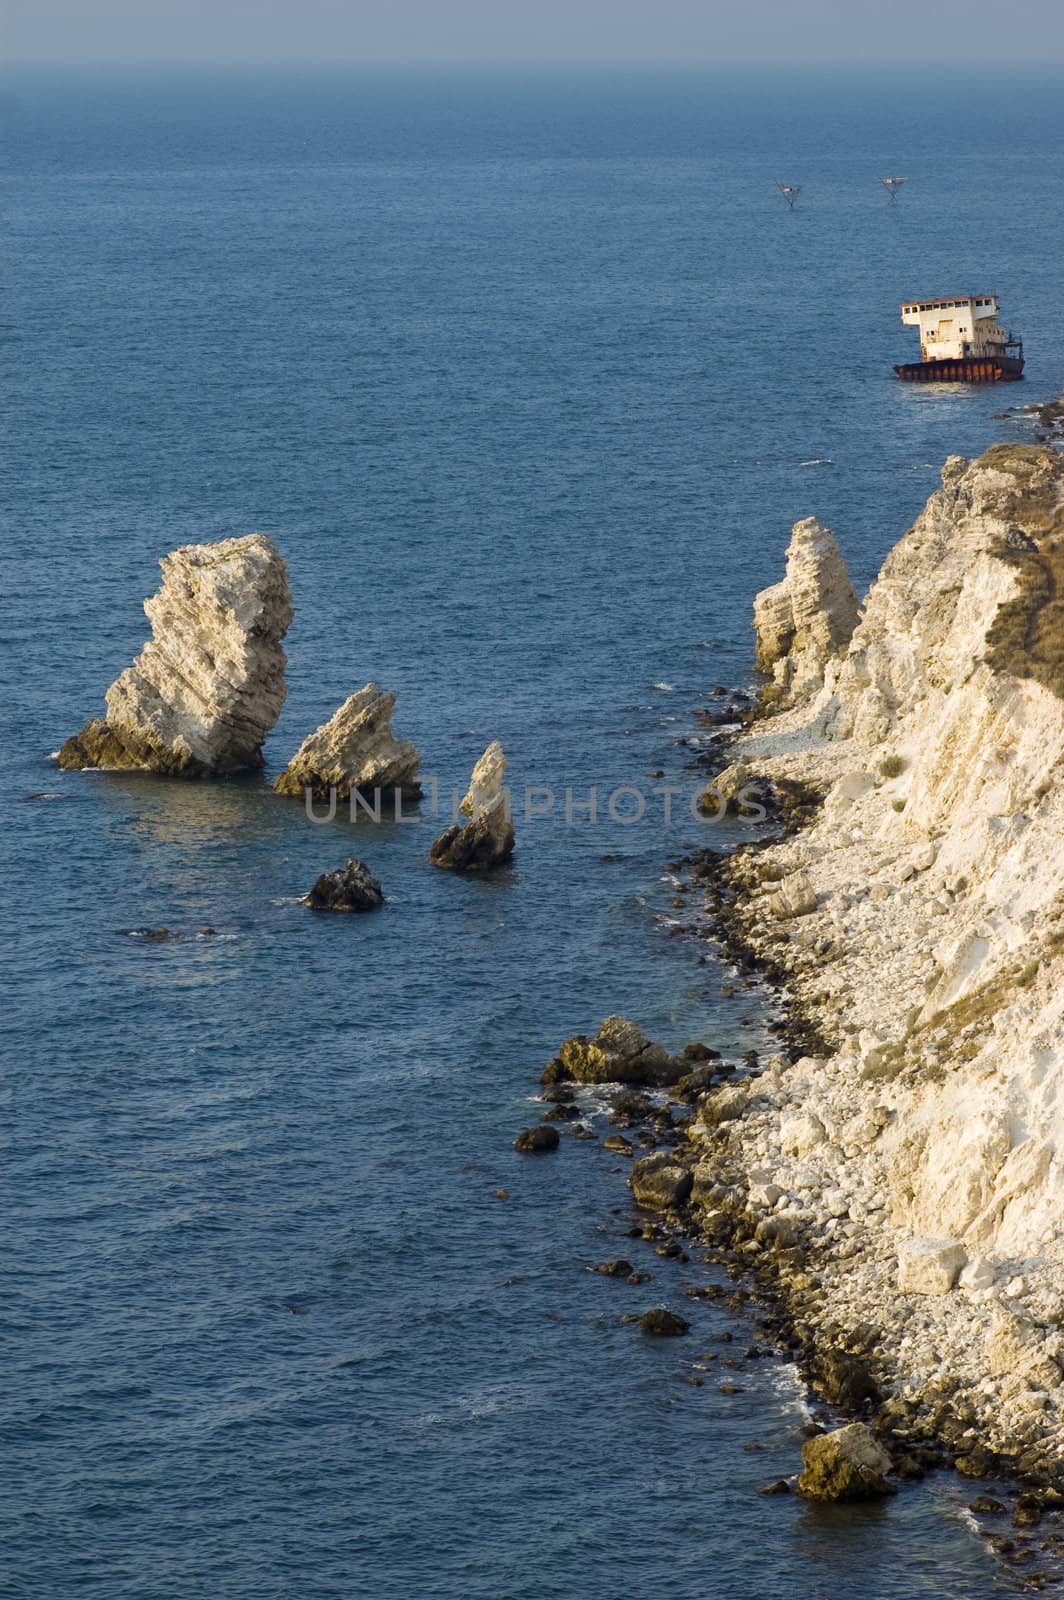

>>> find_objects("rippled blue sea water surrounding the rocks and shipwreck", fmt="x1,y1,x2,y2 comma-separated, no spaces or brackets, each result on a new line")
0,67,1064,1600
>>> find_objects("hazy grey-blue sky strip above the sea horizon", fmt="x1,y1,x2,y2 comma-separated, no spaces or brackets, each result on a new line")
0,0,1064,62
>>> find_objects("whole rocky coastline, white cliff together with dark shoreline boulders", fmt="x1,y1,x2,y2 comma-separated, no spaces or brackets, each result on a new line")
524,446,1064,1589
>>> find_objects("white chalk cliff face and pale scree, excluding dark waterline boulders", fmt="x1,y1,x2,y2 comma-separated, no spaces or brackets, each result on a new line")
707,446,1064,1459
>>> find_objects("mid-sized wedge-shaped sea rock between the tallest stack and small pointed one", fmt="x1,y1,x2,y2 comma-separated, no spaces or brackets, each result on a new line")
274,683,421,800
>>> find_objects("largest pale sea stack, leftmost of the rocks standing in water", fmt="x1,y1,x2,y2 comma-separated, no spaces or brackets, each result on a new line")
59,533,293,778
